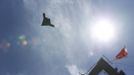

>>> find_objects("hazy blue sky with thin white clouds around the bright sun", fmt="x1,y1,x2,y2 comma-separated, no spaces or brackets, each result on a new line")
0,0,134,75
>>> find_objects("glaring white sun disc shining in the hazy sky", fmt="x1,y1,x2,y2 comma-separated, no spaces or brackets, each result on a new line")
90,18,115,42
